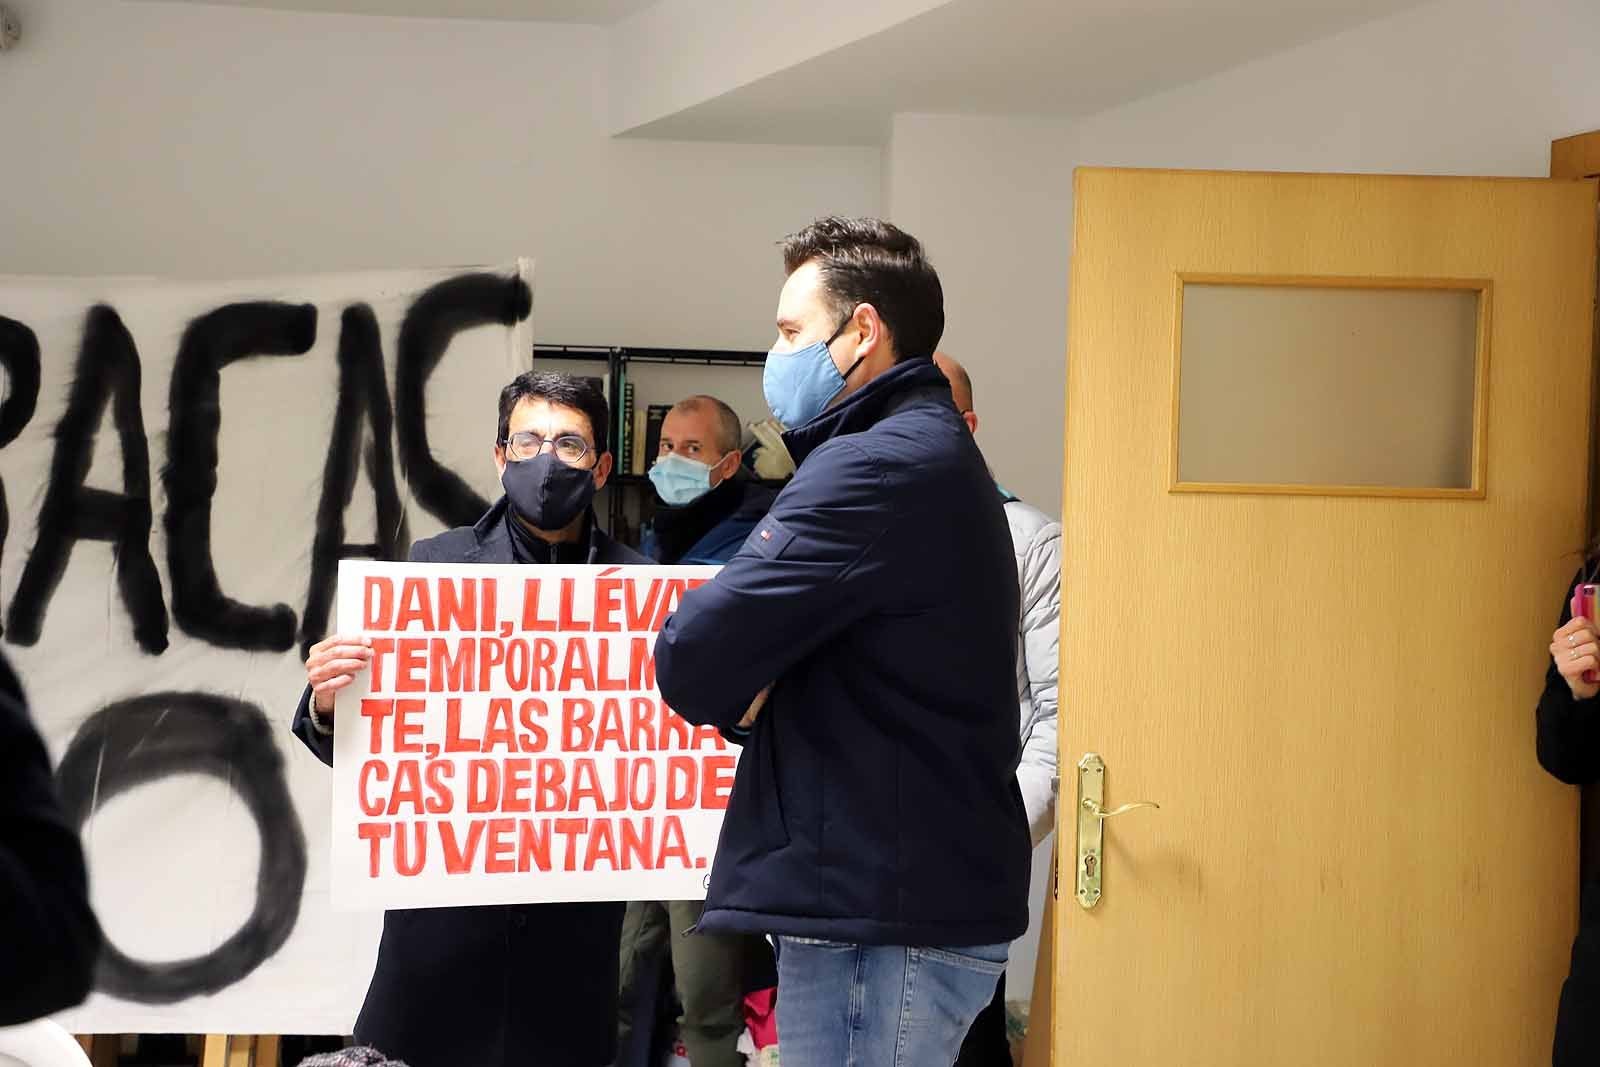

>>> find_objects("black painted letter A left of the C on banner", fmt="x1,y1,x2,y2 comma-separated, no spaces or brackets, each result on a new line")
0,304,166,654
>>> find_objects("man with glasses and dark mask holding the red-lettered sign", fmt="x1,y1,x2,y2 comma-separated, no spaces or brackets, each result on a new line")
293,371,650,1067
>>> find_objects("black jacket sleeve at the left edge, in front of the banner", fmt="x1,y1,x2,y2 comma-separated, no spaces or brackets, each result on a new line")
0,661,101,1025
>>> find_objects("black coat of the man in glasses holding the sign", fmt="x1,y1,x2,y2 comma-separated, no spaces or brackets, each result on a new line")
293,499,650,1067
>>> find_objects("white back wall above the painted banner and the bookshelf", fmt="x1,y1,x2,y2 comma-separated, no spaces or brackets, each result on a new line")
0,0,882,355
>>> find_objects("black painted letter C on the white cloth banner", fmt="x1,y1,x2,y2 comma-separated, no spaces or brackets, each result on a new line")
162,302,317,651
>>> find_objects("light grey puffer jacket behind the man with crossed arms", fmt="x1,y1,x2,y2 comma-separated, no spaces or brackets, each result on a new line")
1005,494,1061,845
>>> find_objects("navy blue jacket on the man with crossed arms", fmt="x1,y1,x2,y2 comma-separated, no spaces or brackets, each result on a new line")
656,360,1032,947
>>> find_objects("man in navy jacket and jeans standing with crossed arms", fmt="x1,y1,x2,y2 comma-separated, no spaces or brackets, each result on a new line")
656,219,1030,1067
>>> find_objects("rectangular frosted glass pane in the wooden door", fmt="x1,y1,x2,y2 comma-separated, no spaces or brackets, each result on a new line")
1178,283,1483,491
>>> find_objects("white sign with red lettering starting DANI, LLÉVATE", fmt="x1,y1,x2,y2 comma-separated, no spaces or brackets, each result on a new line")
333,561,739,910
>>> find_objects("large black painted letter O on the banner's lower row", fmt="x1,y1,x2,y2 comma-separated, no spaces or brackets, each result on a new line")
56,693,306,1005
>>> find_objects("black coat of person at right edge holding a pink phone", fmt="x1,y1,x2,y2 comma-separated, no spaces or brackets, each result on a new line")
1538,571,1600,1067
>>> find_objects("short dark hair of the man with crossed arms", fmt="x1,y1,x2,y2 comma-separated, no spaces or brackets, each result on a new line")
782,214,944,360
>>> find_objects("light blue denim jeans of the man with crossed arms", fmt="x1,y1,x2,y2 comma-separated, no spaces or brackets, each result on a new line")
778,937,1011,1067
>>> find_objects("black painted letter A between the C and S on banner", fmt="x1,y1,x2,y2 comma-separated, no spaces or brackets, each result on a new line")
301,304,411,654
